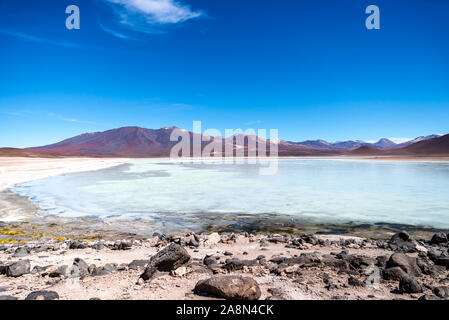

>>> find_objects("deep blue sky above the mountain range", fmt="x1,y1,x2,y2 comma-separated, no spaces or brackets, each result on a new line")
0,0,449,147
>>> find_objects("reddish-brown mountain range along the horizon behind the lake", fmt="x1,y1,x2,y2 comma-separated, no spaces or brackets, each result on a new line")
0,127,449,158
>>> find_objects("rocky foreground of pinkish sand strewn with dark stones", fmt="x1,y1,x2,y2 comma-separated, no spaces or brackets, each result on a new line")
0,232,449,300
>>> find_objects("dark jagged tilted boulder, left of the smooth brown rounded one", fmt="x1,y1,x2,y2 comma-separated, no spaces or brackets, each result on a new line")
140,243,190,280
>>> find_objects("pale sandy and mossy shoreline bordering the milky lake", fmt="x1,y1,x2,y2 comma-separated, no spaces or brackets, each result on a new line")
0,157,449,241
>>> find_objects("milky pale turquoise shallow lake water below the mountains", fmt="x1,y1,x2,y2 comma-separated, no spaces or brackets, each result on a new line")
9,159,449,230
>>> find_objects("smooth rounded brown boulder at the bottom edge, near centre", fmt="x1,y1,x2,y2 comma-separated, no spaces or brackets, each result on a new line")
195,276,261,300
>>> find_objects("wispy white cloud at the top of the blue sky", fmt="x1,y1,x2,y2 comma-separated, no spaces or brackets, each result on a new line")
102,0,204,39
